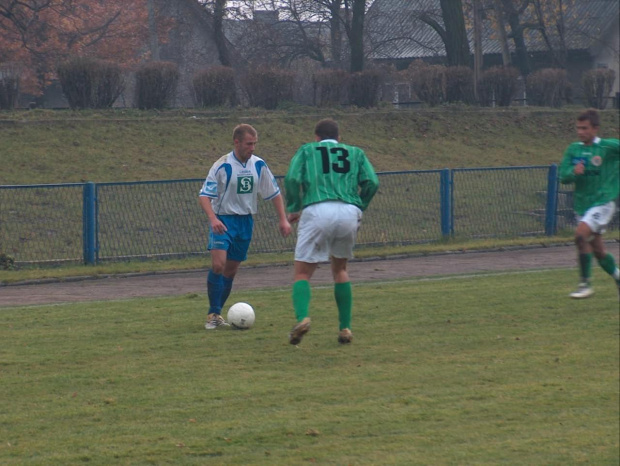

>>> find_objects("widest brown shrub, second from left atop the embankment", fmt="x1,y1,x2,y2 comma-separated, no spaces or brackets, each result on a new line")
57,57,125,109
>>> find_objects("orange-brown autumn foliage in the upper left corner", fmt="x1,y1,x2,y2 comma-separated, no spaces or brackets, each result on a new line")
0,0,169,95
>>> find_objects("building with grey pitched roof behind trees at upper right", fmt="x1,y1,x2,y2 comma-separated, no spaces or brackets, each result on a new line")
366,0,620,104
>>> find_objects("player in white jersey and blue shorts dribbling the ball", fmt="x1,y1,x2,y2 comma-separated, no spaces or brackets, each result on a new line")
199,124,291,330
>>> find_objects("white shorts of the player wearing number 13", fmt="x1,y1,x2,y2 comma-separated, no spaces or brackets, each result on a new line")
295,201,362,264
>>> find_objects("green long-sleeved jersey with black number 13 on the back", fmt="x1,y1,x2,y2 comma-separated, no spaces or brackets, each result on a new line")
284,139,379,212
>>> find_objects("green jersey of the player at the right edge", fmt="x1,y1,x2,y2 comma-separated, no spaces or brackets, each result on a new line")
560,138,620,215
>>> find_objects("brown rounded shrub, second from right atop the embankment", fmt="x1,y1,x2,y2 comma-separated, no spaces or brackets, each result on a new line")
525,68,570,107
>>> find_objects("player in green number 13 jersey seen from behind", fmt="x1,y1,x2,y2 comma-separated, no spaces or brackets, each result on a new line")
284,119,379,345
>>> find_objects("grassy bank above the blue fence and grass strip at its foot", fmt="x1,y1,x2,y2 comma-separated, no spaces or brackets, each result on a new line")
0,107,619,281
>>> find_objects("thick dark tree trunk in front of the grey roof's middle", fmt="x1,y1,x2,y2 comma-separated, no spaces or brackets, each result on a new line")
439,0,471,66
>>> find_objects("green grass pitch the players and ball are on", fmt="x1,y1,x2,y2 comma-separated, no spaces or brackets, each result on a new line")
0,270,620,465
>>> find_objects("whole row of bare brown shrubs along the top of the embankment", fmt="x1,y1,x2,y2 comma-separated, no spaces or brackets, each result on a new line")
0,57,615,109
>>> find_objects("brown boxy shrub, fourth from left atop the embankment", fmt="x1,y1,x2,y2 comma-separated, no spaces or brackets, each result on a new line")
192,66,235,107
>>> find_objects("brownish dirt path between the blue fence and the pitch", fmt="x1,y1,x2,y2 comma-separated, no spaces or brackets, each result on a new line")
0,246,620,307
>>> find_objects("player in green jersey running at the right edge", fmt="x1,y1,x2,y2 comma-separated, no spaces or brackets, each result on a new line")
560,109,620,299
